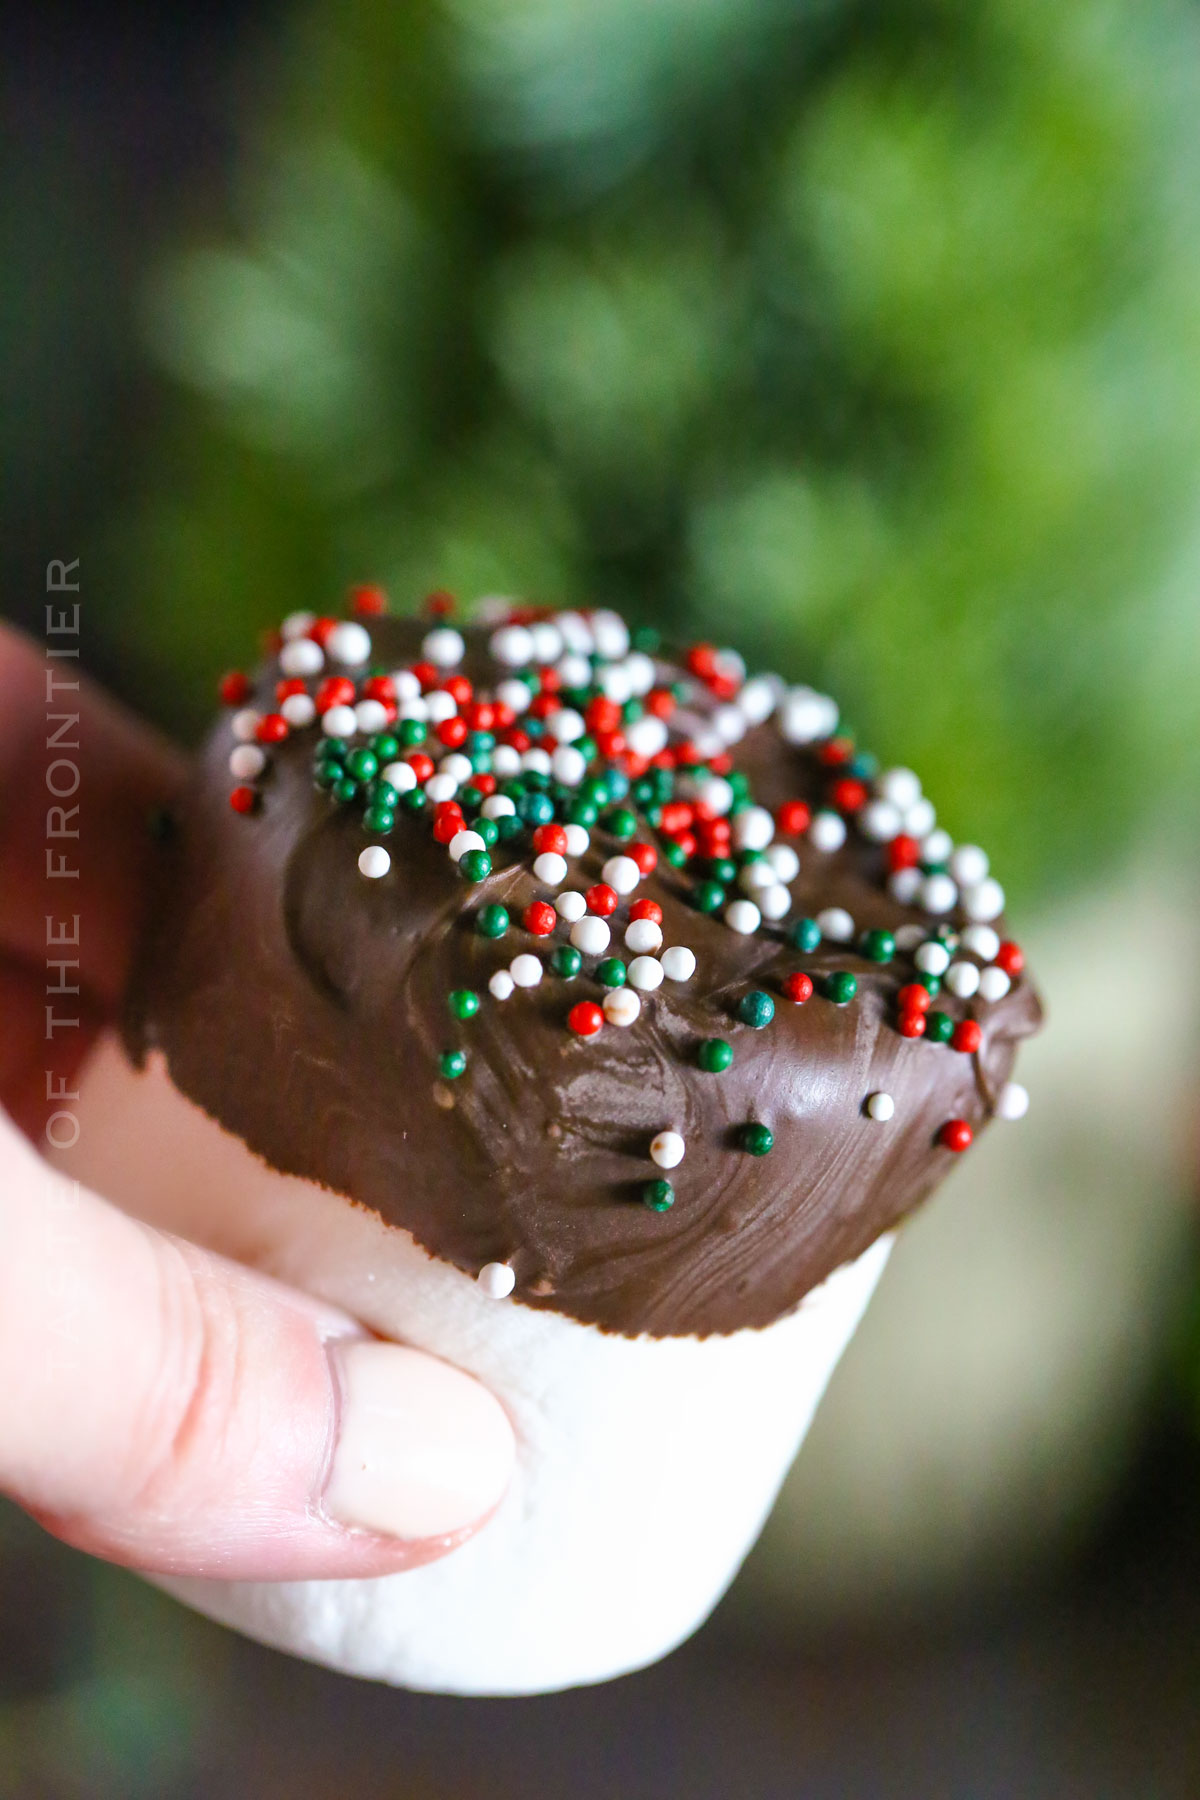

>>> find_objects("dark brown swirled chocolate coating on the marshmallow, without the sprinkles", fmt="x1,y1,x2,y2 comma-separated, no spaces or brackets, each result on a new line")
124,619,1040,1336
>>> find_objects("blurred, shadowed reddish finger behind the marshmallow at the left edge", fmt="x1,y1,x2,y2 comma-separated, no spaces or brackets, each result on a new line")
0,626,182,1008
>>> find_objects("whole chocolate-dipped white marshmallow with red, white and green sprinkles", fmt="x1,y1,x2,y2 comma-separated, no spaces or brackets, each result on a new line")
61,590,1040,1694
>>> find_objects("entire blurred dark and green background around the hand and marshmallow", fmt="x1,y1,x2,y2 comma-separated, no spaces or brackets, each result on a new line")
0,0,1200,1800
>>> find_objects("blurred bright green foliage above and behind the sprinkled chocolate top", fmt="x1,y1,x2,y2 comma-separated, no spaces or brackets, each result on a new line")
107,0,1200,893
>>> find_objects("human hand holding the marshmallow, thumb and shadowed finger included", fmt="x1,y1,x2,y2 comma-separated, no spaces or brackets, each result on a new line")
0,628,513,1580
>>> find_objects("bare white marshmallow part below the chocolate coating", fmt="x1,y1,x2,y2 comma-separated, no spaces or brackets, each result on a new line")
59,1039,891,1696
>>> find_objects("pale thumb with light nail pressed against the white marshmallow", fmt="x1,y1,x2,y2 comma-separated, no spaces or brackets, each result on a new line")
0,1120,513,1580
